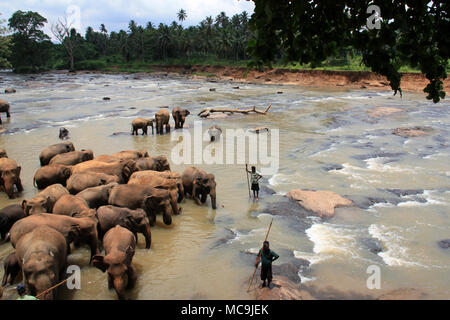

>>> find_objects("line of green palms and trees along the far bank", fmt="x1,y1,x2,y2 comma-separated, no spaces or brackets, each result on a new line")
0,9,252,72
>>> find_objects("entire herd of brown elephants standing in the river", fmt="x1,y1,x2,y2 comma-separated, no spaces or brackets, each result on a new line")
0,100,216,299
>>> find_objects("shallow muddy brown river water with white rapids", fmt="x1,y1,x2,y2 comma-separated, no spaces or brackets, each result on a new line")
0,74,450,299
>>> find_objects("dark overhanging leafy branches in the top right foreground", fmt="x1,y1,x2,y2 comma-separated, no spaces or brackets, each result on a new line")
248,0,450,103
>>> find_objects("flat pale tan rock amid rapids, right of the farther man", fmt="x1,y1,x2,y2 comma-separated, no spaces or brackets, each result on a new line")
286,189,353,218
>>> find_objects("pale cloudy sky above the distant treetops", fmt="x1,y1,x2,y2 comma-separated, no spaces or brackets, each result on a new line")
0,0,254,35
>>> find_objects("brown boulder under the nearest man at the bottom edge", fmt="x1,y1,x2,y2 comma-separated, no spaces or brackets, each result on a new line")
253,276,314,300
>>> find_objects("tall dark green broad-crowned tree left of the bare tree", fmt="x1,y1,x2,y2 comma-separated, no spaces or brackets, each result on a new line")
9,10,52,72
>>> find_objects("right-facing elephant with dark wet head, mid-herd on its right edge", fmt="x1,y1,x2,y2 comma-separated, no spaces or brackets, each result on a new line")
108,184,172,226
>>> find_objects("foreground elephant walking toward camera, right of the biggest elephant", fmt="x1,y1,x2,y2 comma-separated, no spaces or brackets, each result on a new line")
92,225,137,300
